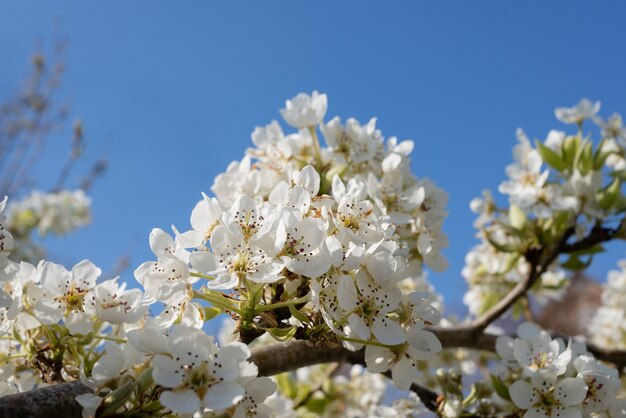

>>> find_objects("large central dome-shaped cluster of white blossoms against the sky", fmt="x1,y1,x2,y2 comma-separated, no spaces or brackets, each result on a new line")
135,93,447,389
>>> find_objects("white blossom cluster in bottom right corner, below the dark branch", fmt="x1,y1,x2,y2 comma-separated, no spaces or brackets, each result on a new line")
493,323,626,418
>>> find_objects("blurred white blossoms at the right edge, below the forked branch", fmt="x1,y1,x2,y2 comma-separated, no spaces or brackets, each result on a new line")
589,260,626,350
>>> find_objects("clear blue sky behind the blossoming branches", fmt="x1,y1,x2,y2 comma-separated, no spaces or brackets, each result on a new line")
0,0,626,311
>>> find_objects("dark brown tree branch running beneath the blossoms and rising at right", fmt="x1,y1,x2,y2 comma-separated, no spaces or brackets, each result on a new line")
0,219,626,418
